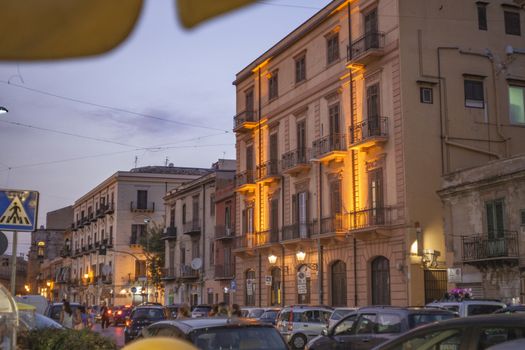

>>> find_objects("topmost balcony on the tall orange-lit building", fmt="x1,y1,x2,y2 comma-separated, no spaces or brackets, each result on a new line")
347,32,385,65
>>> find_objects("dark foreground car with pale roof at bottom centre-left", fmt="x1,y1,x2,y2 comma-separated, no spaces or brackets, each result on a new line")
141,317,288,350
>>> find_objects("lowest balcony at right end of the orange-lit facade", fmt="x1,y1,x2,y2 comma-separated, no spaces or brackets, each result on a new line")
348,207,394,240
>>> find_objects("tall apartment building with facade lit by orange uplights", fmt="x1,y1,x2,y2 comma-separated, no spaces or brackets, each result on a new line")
234,0,525,306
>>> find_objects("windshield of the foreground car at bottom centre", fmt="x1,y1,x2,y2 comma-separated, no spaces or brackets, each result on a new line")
190,327,287,350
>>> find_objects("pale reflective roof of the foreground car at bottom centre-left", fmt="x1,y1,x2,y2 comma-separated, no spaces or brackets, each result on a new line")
150,317,266,333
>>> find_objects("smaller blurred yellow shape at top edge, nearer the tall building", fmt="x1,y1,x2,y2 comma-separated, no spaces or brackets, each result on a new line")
177,0,255,28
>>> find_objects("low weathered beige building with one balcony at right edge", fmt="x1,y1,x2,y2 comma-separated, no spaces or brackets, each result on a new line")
440,155,525,303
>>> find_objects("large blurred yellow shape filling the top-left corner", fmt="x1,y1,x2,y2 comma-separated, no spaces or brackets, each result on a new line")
0,0,142,61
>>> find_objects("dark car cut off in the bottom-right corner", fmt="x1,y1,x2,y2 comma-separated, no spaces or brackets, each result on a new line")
374,314,525,350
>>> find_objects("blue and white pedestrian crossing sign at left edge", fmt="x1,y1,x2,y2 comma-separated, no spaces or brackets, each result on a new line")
0,190,38,232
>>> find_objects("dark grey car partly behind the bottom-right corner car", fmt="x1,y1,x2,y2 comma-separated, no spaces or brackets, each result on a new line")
306,306,457,350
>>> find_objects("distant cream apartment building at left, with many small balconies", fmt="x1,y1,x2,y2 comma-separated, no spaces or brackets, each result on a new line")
64,164,208,305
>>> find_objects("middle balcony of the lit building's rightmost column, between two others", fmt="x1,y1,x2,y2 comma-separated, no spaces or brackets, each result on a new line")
348,117,388,150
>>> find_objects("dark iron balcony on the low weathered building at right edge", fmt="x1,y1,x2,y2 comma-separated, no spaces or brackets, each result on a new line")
461,231,520,267
